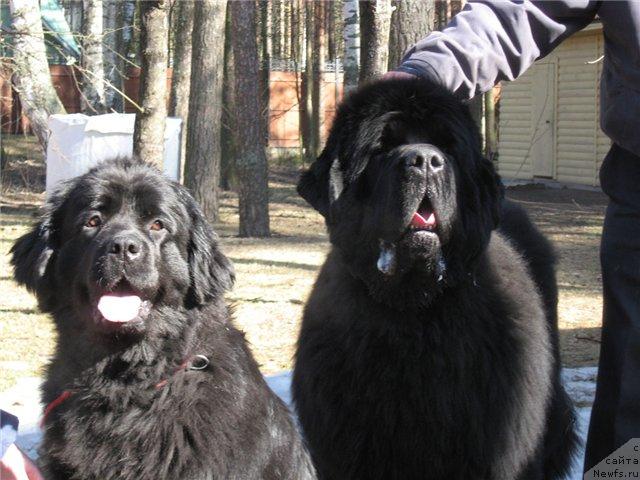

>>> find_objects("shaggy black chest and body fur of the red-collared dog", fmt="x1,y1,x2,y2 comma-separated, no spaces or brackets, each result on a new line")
43,306,312,480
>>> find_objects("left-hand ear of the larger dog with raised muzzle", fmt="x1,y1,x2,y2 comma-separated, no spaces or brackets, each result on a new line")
298,141,344,218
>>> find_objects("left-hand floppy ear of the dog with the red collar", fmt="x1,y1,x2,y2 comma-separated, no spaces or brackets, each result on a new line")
10,182,73,312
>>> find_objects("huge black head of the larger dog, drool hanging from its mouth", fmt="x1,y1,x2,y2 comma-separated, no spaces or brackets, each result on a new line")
297,72,502,308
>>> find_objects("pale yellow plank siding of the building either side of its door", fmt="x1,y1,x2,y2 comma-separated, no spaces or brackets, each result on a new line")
498,28,610,186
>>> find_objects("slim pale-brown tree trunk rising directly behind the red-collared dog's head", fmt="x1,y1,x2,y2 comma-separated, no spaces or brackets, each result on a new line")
133,0,169,166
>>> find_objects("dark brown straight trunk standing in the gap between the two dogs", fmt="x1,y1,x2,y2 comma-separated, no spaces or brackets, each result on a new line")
230,2,270,237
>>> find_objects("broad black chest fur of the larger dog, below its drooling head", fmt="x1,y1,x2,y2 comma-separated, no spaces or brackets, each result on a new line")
294,233,552,479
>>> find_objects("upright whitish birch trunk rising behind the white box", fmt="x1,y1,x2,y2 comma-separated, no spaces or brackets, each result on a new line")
80,0,107,115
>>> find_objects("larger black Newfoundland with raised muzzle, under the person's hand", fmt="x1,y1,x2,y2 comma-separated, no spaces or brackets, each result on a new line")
293,80,576,480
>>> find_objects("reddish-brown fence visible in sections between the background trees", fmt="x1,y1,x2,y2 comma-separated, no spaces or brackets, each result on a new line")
0,65,342,148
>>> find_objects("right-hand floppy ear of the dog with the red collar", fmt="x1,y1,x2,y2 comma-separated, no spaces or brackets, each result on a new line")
179,187,235,305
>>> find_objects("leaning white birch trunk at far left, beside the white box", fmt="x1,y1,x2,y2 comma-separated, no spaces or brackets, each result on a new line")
9,0,66,154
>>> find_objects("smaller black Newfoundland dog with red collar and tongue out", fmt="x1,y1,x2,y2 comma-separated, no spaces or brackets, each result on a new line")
13,160,315,480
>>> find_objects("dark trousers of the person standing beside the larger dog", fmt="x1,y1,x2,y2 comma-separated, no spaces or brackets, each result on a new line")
584,145,640,472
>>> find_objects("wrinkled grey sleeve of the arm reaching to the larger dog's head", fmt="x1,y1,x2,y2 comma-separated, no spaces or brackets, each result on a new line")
397,0,600,99
